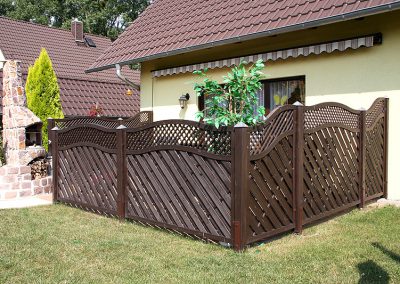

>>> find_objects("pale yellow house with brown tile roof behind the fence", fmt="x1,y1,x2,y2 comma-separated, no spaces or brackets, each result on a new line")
88,0,400,199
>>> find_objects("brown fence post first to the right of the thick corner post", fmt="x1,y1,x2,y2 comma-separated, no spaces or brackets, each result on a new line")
293,103,304,234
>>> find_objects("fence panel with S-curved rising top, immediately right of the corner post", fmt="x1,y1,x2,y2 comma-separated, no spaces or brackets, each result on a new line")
247,106,295,243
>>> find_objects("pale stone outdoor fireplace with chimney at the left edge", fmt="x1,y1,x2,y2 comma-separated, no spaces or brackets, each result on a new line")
0,61,51,200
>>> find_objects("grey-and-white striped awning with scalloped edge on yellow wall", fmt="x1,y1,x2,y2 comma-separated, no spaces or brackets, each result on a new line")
152,34,382,77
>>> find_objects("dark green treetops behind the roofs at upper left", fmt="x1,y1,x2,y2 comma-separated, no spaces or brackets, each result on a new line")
0,0,150,39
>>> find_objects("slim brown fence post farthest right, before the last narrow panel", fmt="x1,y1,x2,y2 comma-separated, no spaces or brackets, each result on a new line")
358,108,367,208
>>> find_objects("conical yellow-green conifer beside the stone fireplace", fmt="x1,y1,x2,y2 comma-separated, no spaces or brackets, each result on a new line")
25,48,64,150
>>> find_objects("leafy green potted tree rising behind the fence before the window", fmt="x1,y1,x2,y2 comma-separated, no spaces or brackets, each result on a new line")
194,60,265,128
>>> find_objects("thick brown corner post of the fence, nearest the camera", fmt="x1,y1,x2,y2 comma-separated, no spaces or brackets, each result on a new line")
231,123,250,251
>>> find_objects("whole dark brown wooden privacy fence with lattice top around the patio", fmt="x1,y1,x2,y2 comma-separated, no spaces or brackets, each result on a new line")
52,99,388,250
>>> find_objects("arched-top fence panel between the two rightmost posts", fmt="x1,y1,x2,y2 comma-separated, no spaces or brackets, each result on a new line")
303,103,361,223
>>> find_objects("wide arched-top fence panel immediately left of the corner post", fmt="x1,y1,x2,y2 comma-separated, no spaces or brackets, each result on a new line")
126,121,232,242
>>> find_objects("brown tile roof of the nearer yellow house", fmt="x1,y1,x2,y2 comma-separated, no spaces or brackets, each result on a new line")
89,0,400,71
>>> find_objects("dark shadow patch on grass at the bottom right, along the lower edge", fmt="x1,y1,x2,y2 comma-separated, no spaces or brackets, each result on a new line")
357,260,390,284
